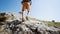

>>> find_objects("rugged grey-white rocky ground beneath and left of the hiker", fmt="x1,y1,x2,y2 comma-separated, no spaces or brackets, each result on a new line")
0,12,60,34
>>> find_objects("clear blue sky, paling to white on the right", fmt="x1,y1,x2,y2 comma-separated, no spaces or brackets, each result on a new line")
0,0,60,22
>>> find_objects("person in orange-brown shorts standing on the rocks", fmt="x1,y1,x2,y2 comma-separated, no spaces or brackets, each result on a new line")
21,0,32,21
